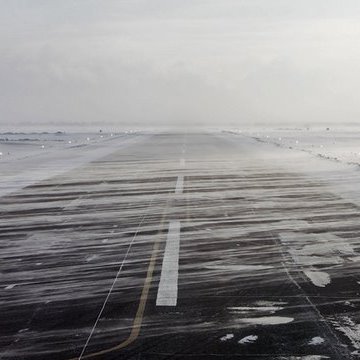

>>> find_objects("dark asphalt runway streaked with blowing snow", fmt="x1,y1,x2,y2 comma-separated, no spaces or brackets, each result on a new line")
0,133,360,360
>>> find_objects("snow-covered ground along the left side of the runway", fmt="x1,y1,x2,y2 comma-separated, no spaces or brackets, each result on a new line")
0,131,149,196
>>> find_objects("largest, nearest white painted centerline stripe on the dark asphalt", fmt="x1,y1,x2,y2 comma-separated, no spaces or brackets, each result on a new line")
156,221,180,306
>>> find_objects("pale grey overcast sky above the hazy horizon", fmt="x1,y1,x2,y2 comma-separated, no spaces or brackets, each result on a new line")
0,0,360,127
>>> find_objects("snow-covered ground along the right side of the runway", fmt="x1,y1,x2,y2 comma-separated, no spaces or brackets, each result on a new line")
224,126,360,205
